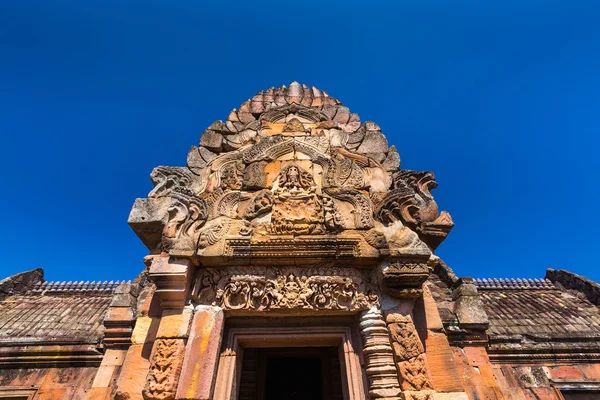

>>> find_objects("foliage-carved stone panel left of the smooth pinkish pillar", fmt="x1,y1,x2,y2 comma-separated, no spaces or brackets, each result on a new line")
142,339,185,400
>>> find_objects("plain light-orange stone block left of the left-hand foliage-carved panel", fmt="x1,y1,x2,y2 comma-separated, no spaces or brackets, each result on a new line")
115,343,152,400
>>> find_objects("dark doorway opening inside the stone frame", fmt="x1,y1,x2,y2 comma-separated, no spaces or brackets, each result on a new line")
238,347,344,400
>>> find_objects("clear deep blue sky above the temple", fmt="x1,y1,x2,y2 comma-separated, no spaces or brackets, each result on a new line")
0,0,600,280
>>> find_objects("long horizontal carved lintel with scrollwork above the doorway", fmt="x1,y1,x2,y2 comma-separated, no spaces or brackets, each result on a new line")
193,267,378,311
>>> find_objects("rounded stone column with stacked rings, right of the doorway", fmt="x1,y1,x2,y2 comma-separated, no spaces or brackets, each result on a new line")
360,307,400,399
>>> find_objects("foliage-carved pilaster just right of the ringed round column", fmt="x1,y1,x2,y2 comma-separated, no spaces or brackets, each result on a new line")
386,314,433,399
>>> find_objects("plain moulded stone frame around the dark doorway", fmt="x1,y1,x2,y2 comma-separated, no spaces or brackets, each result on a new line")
213,326,366,400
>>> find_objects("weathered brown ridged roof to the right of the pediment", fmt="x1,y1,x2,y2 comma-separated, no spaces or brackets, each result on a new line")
426,263,600,354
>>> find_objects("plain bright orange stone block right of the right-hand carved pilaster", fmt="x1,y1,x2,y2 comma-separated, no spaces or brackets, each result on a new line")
425,331,463,392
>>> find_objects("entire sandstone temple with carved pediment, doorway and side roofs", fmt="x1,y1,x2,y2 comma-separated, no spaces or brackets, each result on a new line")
0,82,600,400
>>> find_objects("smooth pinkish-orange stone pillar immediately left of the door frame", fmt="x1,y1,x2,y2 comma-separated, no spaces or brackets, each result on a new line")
177,306,224,400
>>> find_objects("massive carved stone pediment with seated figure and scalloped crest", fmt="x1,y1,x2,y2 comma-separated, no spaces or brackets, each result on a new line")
129,83,453,288
